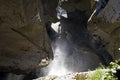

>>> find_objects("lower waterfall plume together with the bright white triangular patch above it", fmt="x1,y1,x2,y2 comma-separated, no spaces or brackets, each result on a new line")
44,22,70,76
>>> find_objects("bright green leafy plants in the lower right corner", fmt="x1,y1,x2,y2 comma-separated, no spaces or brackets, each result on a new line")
87,62,120,80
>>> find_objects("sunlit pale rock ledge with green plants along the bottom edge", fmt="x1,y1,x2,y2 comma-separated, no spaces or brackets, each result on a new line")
33,65,120,80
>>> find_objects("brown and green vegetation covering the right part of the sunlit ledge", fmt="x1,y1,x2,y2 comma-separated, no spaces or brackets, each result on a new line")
74,62,120,80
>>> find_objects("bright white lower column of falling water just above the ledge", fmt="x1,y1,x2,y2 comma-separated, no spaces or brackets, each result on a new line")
48,40,70,76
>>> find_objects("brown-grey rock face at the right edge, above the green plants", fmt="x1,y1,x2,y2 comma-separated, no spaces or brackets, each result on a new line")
88,0,120,60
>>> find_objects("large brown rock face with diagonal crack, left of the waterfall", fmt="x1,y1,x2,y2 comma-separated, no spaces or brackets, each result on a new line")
0,0,52,73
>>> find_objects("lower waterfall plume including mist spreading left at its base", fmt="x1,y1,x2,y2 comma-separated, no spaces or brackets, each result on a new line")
41,38,72,76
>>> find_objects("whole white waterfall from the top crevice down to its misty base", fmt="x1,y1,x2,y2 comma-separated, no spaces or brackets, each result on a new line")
44,0,70,76
